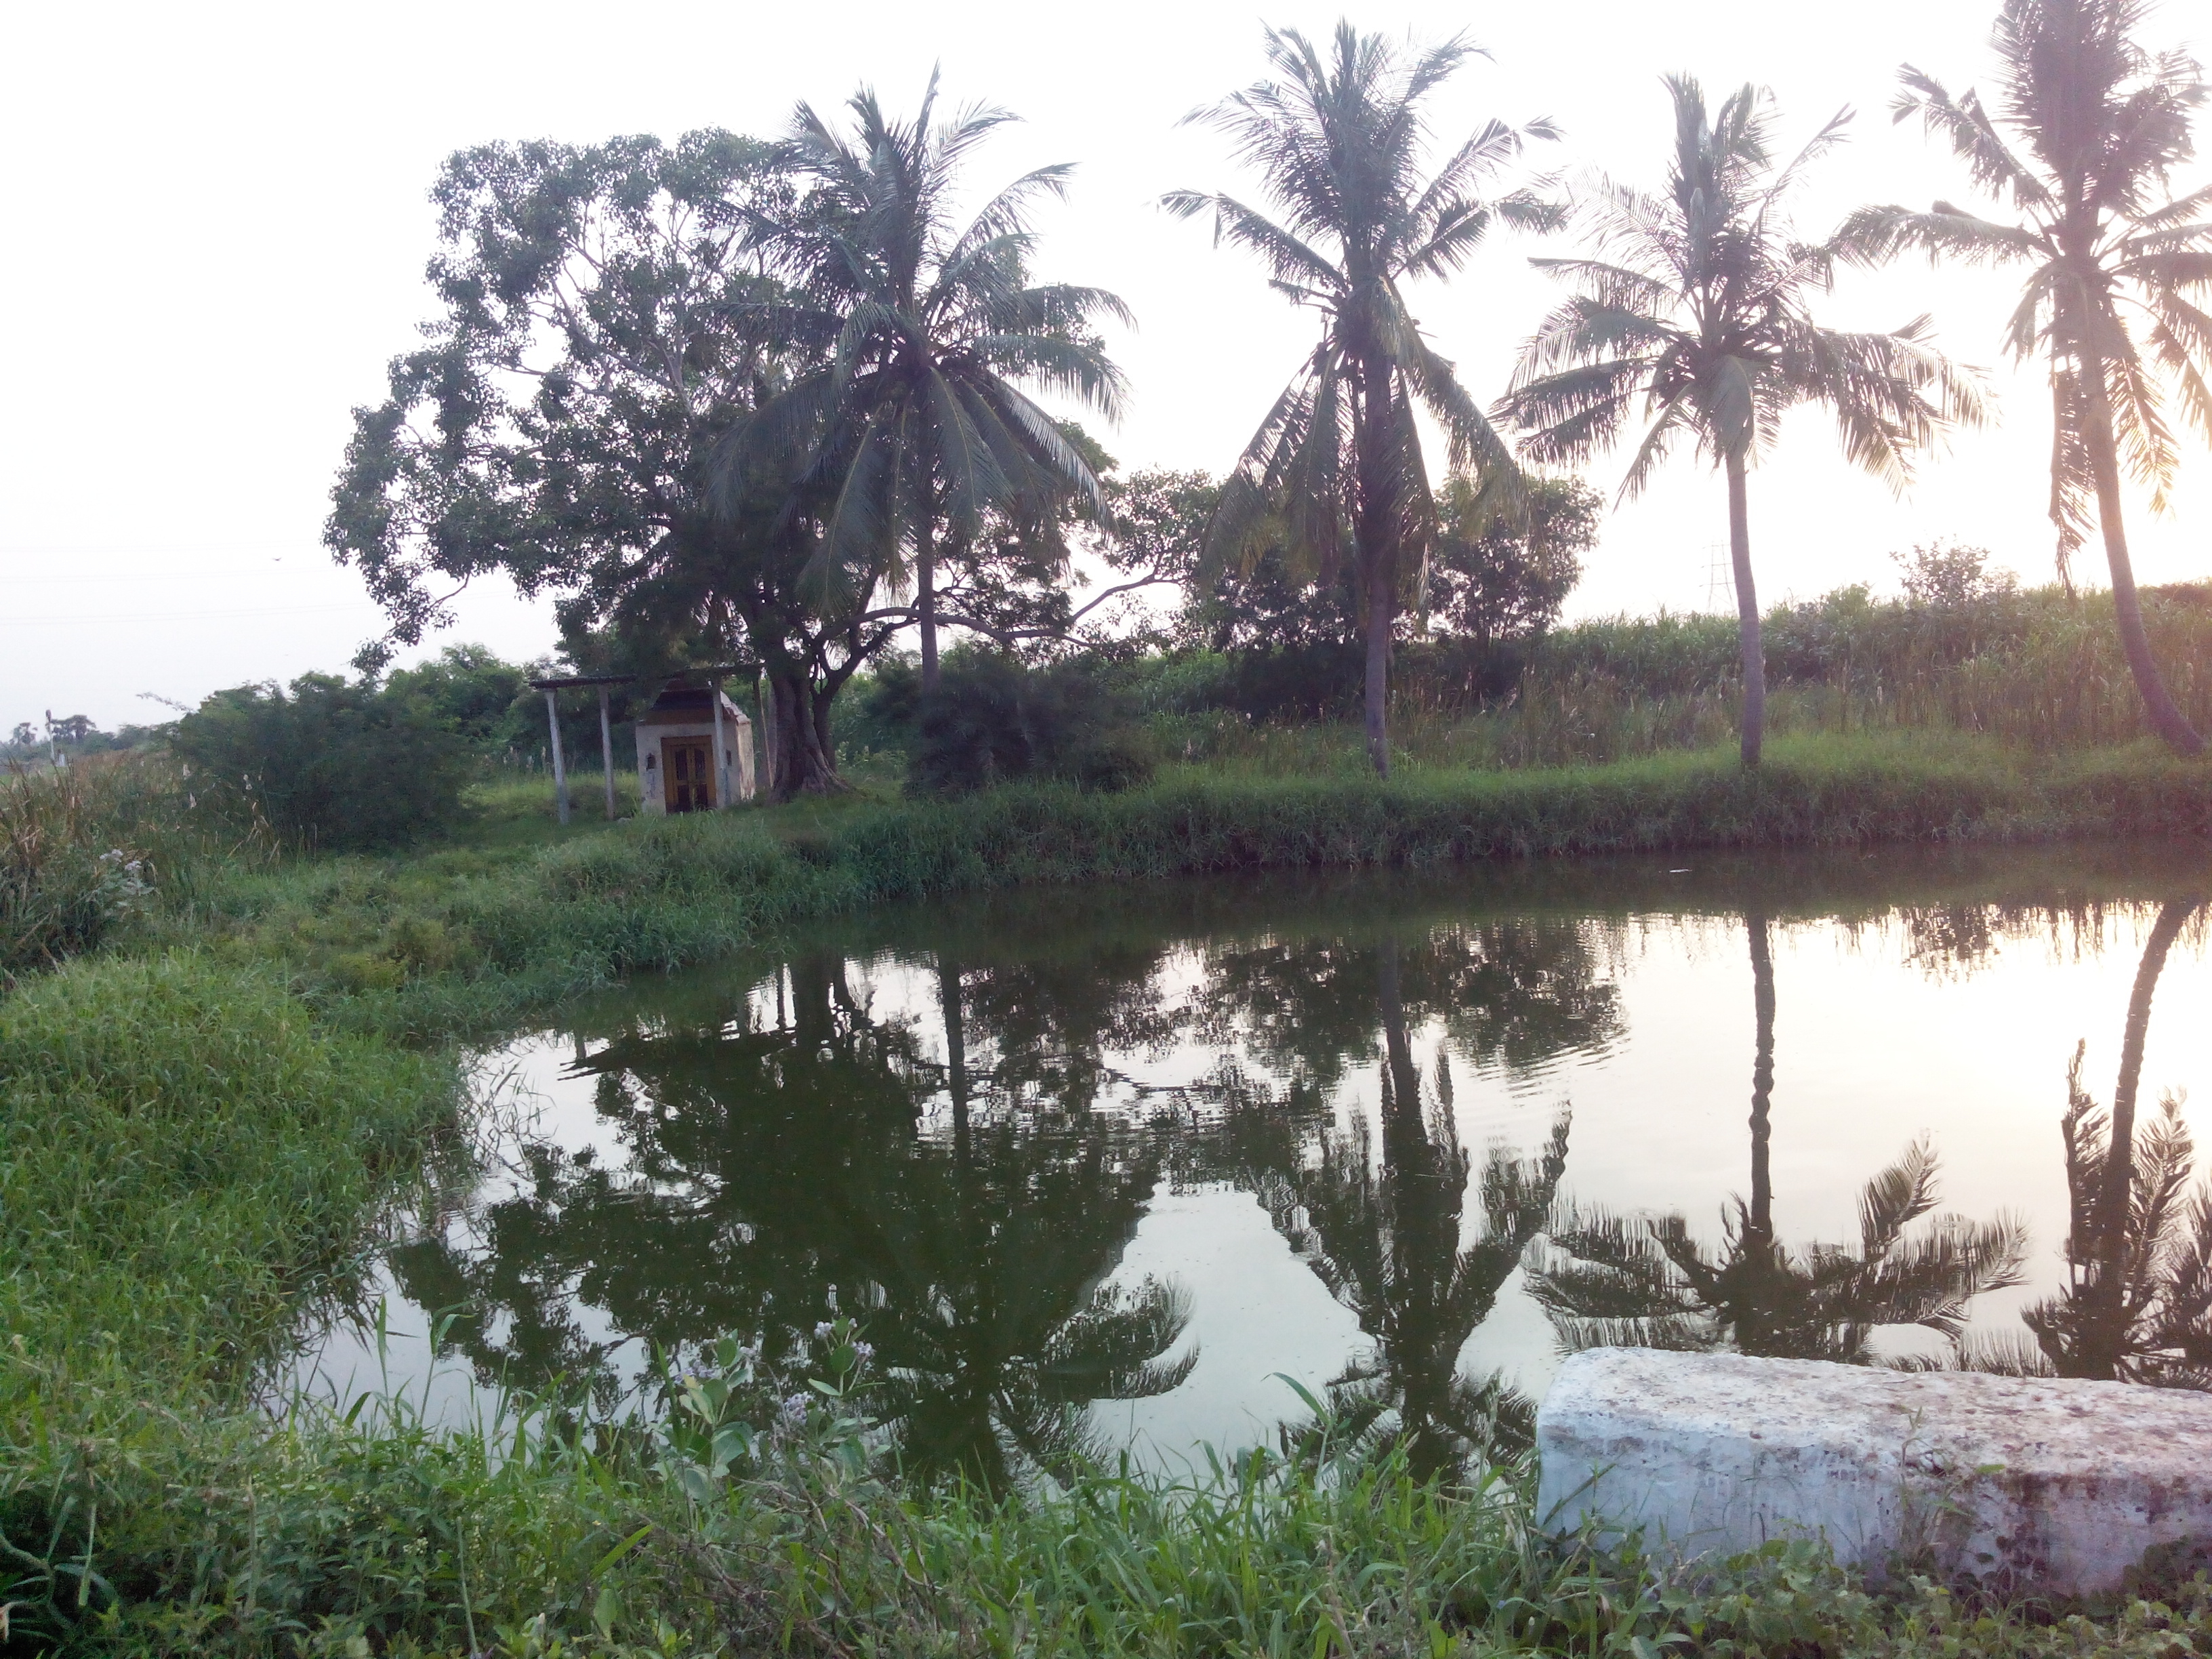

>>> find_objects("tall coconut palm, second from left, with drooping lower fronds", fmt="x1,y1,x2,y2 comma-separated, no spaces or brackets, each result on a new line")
1164,22,1557,777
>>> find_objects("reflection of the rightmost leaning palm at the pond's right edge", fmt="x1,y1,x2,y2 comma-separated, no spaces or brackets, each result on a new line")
1971,898,2212,1389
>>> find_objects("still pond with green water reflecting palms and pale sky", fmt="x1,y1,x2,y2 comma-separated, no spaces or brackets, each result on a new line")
301,845,2212,1467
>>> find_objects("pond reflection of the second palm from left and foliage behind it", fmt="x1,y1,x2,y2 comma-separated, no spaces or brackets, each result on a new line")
1206,920,1619,1475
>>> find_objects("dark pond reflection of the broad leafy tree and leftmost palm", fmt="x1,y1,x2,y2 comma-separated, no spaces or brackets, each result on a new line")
394,958,1195,1480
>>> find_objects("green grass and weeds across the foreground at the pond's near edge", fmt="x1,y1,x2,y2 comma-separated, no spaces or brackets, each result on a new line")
17,1336,2212,1659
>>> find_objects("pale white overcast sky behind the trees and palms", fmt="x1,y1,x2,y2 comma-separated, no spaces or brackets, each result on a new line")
0,0,2212,728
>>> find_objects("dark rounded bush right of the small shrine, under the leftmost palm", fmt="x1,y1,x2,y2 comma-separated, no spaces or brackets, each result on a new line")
907,651,1153,794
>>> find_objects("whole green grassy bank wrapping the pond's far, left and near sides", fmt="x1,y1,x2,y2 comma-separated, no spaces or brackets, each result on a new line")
13,732,2212,1659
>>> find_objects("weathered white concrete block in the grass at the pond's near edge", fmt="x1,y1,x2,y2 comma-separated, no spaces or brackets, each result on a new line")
1537,1347,2212,1595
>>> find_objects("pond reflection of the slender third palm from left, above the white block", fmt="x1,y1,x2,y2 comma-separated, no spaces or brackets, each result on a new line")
1528,909,2028,1365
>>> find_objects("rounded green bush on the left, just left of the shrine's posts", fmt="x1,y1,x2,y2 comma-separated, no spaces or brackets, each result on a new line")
170,675,473,849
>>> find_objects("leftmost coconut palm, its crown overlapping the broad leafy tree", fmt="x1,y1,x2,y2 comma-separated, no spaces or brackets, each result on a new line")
714,75,1130,690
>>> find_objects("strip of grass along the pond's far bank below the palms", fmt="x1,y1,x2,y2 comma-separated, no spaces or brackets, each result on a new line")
170,732,2212,1040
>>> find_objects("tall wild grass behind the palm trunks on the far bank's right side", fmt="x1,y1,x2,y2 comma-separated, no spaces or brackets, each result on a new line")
1141,584,2212,770
